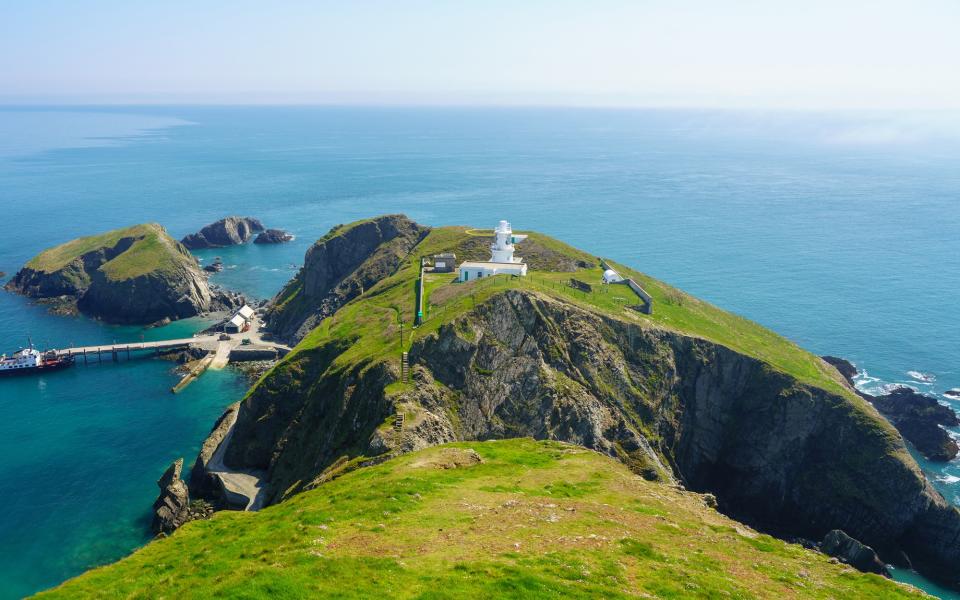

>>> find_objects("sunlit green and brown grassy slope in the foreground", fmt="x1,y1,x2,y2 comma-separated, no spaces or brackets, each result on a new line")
37,440,923,598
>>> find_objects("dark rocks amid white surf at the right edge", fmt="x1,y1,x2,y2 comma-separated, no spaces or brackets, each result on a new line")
823,356,960,462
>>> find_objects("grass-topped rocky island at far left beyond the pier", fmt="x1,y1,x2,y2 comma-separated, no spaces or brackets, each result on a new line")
5,223,242,324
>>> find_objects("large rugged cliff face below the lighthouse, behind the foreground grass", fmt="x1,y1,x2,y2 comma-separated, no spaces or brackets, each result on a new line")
212,291,960,585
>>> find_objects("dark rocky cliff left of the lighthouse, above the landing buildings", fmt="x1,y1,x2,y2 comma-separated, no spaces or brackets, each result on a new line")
267,215,429,342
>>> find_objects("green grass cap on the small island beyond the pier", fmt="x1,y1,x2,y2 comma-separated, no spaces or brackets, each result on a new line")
26,223,190,281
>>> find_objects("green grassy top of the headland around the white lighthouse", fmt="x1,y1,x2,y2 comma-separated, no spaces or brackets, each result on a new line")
294,227,859,401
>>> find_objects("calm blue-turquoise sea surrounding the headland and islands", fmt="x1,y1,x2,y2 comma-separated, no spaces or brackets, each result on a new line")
0,107,960,598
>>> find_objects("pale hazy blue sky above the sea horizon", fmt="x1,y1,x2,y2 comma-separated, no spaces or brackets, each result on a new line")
0,0,960,109
